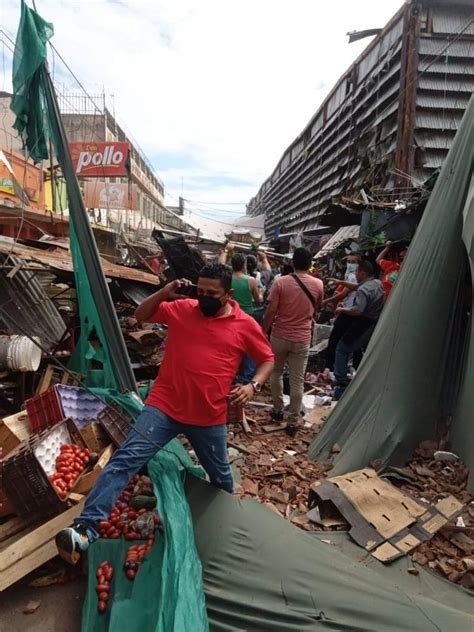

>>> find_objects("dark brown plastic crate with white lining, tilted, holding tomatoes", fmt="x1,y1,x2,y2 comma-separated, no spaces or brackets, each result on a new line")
3,420,71,516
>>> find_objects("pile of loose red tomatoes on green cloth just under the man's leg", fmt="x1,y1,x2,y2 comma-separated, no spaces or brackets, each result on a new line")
99,475,160,540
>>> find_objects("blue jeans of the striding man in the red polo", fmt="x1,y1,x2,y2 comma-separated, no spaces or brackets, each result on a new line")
74,406,234,539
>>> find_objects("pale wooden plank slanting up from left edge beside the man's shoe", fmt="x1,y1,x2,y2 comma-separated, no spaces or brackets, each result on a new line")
0,500,85,590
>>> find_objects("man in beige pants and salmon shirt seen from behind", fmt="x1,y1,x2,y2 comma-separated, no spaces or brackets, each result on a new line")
262,248,324,435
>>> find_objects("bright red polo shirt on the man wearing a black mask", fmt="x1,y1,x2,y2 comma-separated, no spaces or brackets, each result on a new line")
146,299,273,426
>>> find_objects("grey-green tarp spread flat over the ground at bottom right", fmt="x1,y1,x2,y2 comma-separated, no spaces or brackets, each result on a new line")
192,477,474,632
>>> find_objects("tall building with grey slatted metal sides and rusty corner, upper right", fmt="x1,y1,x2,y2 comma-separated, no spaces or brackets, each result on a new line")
248,0,474,237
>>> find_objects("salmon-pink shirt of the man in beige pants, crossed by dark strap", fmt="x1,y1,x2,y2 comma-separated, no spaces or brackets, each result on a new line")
268,274,324,344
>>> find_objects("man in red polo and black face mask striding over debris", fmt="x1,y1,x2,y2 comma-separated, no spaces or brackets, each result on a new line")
56,264,273,563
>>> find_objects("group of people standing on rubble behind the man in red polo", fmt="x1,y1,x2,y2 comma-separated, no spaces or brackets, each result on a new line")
219,242,405,434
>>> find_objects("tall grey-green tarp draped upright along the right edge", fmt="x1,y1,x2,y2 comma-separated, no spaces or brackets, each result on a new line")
309,98,474,474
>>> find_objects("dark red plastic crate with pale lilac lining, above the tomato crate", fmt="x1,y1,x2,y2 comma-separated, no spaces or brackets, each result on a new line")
26,384,106,432
